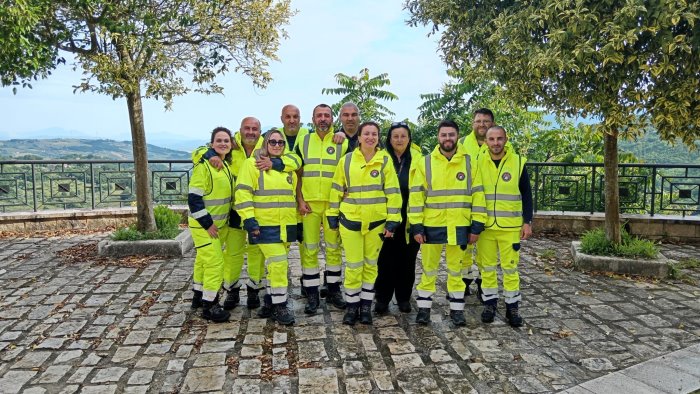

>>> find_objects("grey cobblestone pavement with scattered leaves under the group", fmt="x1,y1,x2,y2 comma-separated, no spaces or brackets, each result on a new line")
0,234,700,394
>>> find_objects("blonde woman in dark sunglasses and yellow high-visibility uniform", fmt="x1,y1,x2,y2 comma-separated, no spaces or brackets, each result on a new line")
235,129,297,325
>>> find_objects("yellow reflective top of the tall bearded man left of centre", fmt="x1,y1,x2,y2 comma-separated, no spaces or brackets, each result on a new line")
296,127,348,201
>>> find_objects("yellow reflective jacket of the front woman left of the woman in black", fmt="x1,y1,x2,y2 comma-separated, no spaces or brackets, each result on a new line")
327,149,401,233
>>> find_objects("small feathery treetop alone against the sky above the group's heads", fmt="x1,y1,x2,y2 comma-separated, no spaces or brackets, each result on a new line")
321,68,398,123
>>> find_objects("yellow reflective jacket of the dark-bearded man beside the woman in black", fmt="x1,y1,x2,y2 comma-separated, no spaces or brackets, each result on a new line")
408,144,486,245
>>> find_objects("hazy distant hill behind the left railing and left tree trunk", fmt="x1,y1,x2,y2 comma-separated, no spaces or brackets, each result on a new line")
0,138,190,160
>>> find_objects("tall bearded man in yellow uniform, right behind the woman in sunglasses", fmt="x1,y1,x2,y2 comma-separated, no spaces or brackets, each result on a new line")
296,104,348,314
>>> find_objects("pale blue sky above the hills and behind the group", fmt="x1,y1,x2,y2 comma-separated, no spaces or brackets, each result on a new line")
0,0,449,149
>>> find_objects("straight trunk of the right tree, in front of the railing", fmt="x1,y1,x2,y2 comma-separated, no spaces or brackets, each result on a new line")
604,130,622,244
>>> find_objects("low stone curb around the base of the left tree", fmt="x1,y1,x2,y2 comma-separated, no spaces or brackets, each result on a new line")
97,229,194,257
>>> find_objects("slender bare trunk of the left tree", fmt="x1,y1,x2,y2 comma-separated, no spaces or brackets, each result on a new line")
126,84,156,232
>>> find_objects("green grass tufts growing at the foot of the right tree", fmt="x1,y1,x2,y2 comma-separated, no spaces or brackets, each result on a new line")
581,228,659,259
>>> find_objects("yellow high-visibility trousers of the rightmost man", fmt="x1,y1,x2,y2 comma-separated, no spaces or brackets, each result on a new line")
476,229,521,304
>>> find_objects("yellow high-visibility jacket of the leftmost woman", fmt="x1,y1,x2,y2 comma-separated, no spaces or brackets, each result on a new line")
187,161,233,229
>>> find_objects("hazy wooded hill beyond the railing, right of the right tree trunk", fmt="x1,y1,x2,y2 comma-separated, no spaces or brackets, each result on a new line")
618,131,700,164
